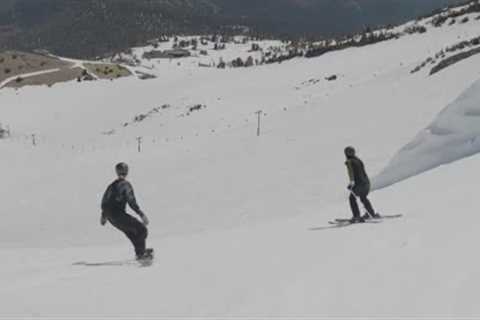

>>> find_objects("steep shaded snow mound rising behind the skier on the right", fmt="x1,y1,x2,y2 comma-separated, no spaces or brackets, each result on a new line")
373,80,480,190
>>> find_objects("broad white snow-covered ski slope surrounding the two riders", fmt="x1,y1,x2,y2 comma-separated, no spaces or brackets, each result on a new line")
0,1,480,319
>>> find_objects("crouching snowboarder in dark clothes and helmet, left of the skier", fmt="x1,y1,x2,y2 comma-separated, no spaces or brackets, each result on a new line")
100,162,153,260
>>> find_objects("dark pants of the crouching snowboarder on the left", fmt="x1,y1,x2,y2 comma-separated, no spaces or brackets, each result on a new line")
107,211,148,255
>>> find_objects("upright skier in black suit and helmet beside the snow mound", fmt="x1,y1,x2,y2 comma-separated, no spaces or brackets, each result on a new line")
345,147,380,223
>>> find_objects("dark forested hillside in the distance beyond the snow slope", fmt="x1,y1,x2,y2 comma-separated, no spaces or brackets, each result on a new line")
0,0,464,58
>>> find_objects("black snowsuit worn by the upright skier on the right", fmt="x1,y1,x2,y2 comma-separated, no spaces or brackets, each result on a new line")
345,156,375,218
